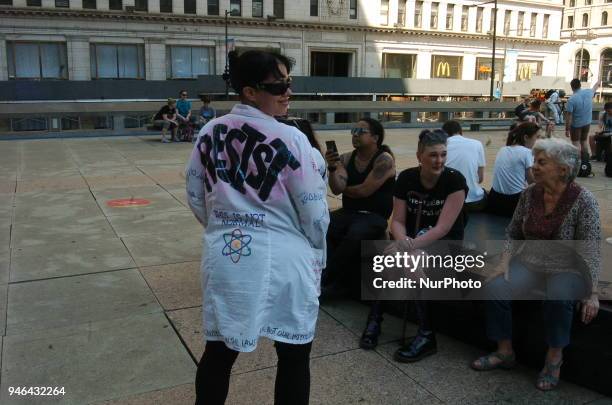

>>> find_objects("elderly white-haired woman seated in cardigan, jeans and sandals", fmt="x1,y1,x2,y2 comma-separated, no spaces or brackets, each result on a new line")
471,139,601,391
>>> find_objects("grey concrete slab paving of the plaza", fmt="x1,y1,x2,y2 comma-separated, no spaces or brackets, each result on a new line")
0,129,612,405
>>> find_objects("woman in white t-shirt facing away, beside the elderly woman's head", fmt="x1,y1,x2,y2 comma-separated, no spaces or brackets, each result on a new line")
487,122,540,218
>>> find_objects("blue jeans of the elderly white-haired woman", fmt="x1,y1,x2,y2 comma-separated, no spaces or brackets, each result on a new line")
485,259,587,348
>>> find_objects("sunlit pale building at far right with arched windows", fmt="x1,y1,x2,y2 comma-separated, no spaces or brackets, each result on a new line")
559,0,612,95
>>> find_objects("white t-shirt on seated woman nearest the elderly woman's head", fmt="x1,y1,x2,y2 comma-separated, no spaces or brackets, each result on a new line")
492,145,533,195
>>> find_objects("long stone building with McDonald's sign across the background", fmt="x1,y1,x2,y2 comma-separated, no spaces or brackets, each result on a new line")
0,0,564,88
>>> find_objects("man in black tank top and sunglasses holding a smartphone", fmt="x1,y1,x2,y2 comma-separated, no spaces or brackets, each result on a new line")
322,118,395,297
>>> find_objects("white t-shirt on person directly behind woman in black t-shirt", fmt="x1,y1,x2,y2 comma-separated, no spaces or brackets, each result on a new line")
446,135,486,203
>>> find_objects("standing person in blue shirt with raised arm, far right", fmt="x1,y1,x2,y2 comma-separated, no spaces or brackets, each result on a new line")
565,79,601,161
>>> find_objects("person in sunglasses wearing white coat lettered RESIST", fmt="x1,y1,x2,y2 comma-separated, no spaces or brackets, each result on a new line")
186,51,329,404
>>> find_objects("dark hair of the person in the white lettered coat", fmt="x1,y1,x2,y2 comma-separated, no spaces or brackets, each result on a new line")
227,50,293,96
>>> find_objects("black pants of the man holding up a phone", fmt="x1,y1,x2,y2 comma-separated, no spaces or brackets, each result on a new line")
323,209,387,287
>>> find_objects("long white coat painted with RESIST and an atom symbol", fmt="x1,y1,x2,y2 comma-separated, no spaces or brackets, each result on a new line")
186,104,329,352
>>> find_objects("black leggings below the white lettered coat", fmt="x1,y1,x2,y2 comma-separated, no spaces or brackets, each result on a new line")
196,341,312,405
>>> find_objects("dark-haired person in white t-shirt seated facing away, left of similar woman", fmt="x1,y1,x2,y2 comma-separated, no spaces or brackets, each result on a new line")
442,121,487,212
